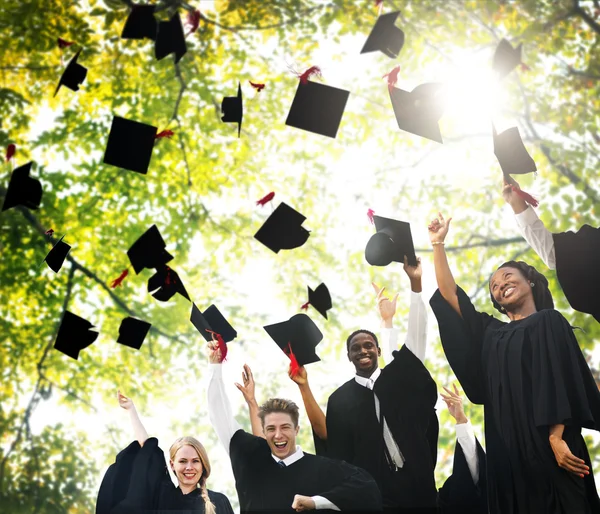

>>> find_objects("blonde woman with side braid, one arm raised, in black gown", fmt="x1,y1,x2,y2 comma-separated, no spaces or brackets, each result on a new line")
96,391,233,514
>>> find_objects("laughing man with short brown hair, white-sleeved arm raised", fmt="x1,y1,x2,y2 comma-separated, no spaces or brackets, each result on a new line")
208,344,382,514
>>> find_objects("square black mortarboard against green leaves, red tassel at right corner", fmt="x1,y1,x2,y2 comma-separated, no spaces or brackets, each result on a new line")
104,116,157,175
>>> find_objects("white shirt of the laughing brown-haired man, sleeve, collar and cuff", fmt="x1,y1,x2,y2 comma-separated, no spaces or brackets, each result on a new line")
208,364,340,511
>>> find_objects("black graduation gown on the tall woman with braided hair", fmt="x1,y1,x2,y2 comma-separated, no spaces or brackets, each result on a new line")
430,288,600,514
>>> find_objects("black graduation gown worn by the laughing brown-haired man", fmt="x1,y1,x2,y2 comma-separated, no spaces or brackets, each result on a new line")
229,429,381,514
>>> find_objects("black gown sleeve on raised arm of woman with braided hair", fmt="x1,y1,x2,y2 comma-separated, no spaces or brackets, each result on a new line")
429,287,503,404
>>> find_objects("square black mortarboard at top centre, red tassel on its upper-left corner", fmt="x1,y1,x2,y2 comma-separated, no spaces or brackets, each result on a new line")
285,80,350,138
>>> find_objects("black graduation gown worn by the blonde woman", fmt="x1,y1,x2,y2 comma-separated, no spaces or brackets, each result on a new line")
96,437,233,514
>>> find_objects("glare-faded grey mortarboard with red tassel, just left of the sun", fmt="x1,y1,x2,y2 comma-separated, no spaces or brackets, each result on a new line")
390,83,444,143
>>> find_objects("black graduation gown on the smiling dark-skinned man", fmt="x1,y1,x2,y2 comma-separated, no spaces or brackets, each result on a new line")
315,346,439,514
